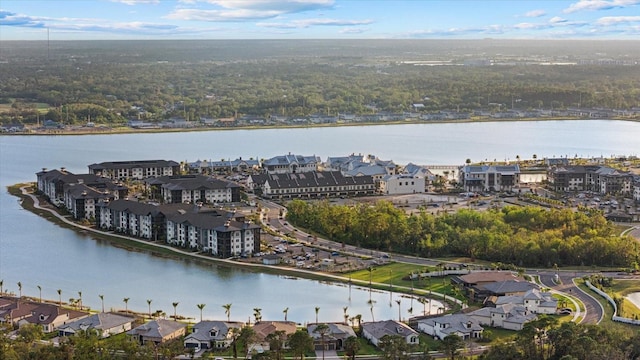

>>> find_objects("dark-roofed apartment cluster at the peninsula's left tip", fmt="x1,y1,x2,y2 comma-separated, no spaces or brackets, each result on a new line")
36,168,129,219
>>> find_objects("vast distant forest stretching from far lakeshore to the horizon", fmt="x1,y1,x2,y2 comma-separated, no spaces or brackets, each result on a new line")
0,40,640,125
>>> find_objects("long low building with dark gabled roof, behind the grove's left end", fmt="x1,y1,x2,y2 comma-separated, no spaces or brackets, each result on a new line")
247,171,375,199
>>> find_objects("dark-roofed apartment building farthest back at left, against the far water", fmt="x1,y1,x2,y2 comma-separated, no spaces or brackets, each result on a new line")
89,160,180,181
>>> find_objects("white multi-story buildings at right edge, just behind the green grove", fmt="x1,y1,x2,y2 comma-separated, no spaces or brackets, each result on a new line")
548,165,636,195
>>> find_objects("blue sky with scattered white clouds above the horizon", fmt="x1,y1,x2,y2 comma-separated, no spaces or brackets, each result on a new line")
0,0,640,40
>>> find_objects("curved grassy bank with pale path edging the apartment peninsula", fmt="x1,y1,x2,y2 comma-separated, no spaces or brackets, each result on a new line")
8,183,461,306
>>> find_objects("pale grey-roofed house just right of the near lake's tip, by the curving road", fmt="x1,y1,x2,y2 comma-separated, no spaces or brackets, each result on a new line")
467,304,537,331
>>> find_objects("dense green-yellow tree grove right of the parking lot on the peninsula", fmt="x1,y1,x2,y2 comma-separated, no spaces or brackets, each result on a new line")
287,200,640,267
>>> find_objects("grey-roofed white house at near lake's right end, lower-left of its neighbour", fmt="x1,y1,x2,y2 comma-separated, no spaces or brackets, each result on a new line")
418,314,484,340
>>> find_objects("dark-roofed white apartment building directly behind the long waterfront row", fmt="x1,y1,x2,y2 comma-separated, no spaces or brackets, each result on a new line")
145,175,240,204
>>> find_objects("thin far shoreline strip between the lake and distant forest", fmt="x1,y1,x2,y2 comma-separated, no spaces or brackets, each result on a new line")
0,117,640,136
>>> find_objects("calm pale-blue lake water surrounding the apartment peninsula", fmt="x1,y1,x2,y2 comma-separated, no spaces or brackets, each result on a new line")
0,120,640,323
